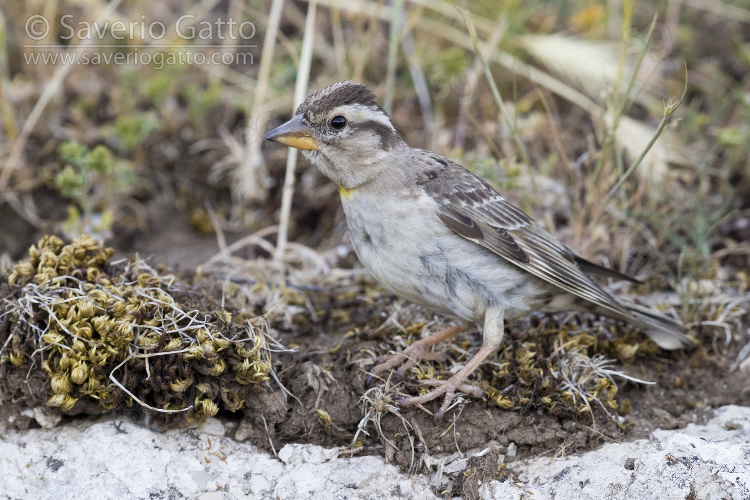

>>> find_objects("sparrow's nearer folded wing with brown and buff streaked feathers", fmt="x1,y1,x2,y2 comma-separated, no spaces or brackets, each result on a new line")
419,155,637,322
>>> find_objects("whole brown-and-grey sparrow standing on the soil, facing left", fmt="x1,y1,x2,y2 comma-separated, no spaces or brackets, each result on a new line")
264,81,691,418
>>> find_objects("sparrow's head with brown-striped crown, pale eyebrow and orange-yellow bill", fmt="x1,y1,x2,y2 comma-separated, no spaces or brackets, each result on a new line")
263,80,405,189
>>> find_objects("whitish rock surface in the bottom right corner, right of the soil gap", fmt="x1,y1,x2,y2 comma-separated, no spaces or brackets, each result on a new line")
480,406,750,500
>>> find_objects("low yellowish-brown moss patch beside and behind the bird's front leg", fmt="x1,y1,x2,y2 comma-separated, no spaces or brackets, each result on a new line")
394,317,658,417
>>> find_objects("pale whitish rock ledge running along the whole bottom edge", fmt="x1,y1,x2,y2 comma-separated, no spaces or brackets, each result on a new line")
0,406,750,500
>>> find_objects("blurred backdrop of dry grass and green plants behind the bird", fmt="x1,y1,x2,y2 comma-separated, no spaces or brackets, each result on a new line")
0,0,750,286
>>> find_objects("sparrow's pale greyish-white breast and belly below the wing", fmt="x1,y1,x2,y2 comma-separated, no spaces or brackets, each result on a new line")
342,191,540,324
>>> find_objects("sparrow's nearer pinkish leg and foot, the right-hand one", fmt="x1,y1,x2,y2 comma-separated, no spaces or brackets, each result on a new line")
399,307,505,420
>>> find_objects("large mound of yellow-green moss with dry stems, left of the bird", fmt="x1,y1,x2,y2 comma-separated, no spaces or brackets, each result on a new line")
0,236,271,424
